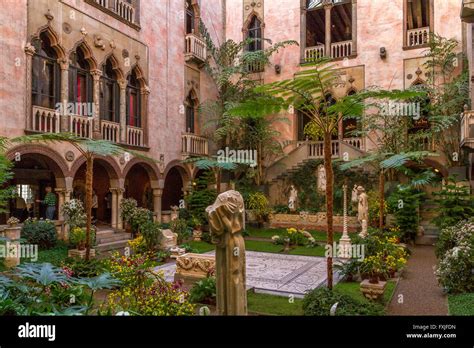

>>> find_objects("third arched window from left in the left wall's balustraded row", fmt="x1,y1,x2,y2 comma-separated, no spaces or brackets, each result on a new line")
100,58,120,123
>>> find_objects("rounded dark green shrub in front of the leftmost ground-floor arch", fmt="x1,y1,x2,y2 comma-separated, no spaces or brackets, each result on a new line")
21,219,57,249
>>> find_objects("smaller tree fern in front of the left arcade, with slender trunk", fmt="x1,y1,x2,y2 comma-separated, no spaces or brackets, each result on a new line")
11,133,153,261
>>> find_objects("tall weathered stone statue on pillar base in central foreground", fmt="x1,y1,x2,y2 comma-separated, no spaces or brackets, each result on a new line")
206,191,247,315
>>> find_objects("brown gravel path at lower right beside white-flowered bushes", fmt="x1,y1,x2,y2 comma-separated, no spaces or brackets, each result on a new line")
388,246,448,315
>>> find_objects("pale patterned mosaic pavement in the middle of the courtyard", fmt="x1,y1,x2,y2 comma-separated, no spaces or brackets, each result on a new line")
155,251,337,298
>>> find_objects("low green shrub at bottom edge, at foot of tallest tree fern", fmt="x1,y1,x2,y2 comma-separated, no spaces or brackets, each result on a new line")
303,288,383,316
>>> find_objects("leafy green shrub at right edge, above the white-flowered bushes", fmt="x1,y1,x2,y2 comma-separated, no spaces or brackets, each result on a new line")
433,178,474,228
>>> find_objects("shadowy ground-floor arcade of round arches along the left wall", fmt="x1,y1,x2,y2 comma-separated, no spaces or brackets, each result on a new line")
0,145,191,230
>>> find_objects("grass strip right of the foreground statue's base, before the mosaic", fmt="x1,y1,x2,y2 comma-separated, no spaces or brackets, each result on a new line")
247,292,303,316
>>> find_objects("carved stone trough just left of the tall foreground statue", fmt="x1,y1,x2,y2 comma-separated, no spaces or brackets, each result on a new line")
174,253,216,289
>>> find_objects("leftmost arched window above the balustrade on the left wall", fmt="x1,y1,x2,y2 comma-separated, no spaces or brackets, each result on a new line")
31,32,61,109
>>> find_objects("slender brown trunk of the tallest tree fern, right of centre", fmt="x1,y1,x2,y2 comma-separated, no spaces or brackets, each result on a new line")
324,133,335,290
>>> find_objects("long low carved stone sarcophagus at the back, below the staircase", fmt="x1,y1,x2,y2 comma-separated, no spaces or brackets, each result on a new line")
270,213,359,232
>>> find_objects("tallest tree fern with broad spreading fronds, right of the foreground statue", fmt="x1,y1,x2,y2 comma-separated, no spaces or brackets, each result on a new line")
228,58,418,289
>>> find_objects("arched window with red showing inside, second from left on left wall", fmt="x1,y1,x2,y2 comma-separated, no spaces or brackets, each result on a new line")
69,48,93,116
